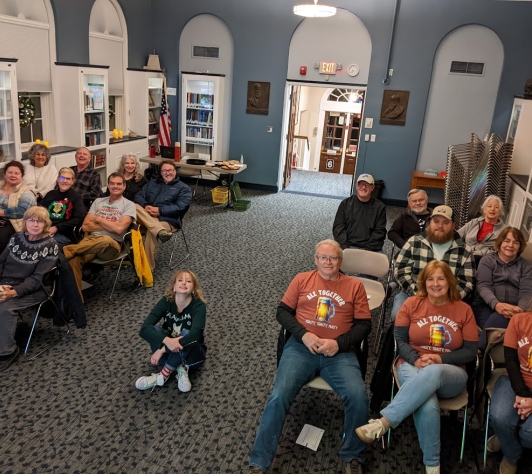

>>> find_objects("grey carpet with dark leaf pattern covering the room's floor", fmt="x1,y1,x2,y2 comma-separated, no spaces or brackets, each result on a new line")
0,190,532,474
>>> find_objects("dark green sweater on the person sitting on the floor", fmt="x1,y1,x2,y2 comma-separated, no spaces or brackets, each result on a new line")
140,297,207,347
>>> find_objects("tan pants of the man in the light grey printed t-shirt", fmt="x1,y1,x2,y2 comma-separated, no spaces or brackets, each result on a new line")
63,235,121,300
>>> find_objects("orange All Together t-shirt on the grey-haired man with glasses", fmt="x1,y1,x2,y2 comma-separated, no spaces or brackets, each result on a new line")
281,270,371,339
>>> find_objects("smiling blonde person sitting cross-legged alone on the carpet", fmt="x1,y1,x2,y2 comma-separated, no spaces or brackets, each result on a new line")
135,270,207,392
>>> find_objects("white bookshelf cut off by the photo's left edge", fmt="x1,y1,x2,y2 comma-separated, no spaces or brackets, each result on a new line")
0,59,21,168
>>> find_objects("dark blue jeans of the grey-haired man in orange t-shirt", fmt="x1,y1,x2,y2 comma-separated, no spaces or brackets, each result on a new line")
249,337,368,471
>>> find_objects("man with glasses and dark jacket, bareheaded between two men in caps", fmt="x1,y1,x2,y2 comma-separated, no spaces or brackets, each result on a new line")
388,189,432,250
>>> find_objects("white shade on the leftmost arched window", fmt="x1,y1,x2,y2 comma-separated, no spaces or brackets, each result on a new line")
0,19,52,92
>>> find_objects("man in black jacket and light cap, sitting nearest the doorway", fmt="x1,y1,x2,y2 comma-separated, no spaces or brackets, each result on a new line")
333,174,386,252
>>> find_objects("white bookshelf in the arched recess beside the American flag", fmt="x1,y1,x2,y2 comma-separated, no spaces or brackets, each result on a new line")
181,73,227,161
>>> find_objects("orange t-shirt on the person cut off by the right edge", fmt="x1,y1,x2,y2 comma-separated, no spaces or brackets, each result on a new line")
504,313,532,388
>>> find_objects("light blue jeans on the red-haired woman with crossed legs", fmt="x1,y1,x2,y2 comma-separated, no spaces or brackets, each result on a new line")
381,362,467,466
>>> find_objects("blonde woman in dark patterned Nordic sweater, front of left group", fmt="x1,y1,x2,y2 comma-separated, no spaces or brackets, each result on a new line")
0,206,59,372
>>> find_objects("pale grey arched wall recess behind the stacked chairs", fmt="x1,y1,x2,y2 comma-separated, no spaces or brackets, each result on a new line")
416,25,504,170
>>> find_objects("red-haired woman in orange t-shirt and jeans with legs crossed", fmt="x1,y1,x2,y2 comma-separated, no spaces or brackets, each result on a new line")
356,260,478,474
